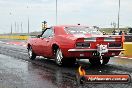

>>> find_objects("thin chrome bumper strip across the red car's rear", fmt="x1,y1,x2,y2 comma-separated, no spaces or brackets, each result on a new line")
68,49,125,52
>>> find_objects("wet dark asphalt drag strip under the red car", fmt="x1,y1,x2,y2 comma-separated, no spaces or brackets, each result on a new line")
0,40,132,88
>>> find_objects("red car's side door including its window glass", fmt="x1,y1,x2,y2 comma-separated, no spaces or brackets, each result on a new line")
39,28,53,57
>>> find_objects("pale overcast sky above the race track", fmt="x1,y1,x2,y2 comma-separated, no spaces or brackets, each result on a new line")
0,0,132,34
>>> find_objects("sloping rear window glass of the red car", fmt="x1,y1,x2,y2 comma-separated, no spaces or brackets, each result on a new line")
65,27,102,35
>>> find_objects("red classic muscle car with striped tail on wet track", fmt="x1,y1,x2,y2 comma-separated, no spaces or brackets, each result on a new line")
27,25,124,66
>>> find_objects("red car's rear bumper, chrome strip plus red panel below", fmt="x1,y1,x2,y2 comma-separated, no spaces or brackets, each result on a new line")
61,49,124,59
